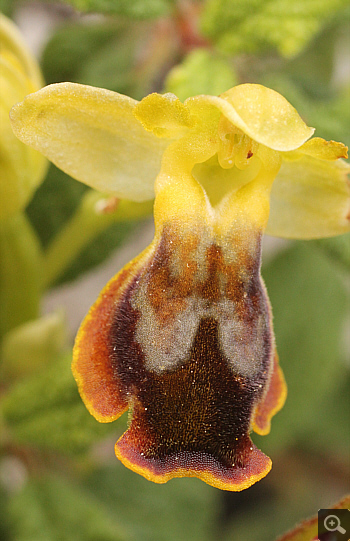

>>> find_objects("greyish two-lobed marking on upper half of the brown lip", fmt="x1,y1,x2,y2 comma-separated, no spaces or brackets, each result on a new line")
132,226,271,377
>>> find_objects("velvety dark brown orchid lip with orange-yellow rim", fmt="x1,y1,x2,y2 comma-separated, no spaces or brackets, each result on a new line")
74,219,285,491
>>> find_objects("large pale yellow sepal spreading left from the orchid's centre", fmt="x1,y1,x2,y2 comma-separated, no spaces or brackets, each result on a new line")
11,83,168,201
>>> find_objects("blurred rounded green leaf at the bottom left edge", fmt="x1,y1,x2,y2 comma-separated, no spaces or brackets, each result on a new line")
8,476,128,541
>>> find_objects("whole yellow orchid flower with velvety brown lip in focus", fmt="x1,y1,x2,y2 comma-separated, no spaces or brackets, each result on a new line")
11,83,350,491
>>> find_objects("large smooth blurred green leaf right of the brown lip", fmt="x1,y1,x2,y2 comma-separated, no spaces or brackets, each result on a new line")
254,242,349,456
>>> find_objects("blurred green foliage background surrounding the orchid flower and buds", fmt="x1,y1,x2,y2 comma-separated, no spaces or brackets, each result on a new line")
0,0,350,541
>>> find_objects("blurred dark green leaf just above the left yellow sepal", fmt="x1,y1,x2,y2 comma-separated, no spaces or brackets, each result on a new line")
42,19,176,99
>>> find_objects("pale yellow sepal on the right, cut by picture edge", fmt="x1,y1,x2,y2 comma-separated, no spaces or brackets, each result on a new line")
266,156,350,235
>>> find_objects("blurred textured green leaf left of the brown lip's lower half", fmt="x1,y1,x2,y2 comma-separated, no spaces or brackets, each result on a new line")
0,357,125,453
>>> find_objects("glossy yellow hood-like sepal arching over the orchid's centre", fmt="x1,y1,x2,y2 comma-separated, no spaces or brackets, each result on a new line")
191,84,314,151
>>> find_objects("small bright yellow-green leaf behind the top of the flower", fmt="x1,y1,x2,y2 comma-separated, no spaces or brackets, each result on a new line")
165,49,237,101
